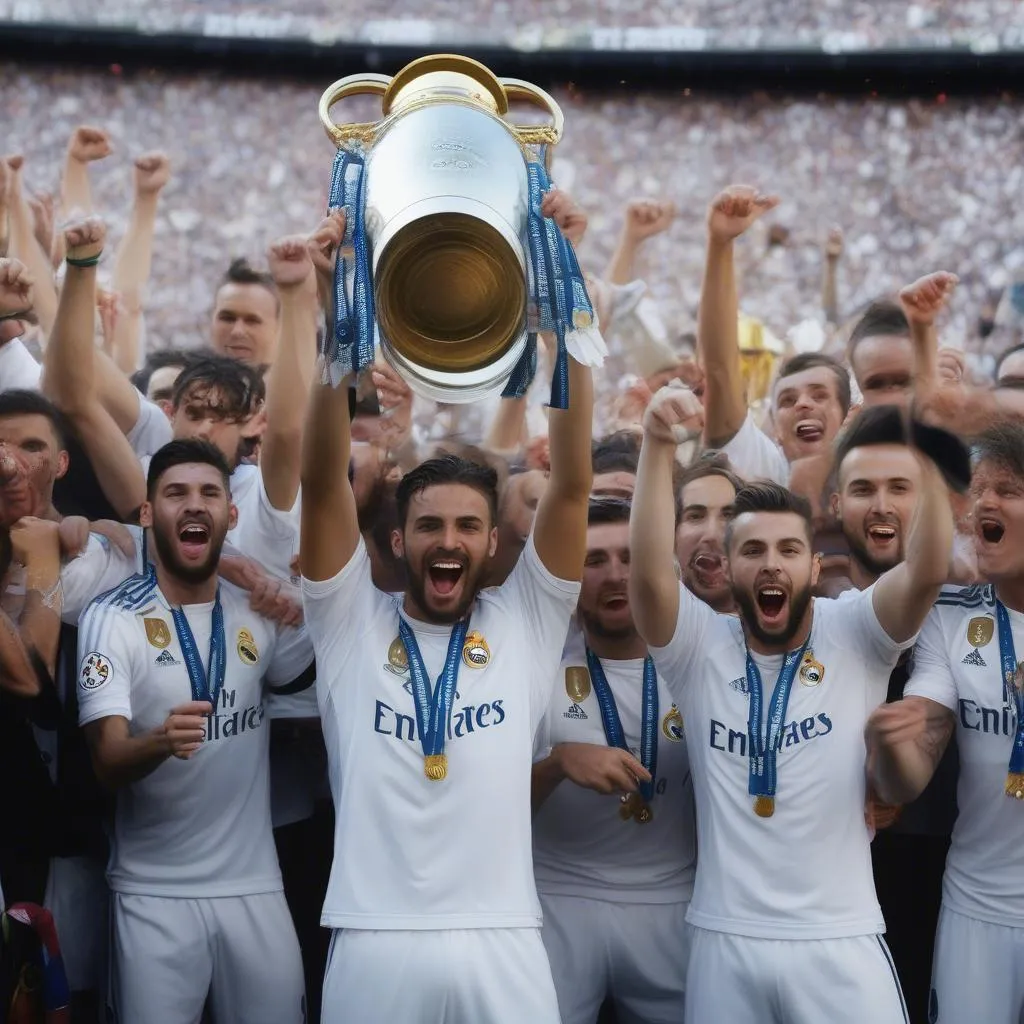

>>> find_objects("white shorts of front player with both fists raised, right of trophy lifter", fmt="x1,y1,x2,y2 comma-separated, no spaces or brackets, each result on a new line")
686,928,909,1024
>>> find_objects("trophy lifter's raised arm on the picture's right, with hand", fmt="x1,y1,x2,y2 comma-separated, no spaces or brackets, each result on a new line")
534,189,594,580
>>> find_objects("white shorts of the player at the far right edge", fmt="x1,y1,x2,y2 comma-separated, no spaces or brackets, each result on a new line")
928,906,1024,1024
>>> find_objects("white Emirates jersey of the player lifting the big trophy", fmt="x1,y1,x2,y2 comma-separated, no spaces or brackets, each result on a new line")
302,538,580,929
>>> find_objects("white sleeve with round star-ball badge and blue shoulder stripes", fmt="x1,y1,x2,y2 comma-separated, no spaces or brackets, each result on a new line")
78,602,134,725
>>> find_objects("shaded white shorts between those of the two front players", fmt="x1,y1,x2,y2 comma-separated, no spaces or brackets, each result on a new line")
541,894,692,1024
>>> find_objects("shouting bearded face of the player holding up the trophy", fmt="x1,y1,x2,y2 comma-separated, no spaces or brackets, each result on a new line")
391,483,498,623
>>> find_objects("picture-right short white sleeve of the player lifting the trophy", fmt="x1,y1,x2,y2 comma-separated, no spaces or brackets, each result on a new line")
499,532,580,725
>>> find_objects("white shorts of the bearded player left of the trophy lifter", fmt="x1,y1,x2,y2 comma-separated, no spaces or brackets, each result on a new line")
111,892,306,1024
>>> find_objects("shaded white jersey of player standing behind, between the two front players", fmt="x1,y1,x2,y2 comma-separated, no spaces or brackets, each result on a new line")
534,629,696,903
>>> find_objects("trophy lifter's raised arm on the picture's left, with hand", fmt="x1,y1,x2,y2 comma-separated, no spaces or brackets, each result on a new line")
299,212,359,580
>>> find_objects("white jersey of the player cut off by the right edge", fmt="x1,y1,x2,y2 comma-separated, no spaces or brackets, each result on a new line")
904,587,1024,928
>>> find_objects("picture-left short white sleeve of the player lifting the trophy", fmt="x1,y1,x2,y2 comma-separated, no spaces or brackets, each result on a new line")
302,537,390,685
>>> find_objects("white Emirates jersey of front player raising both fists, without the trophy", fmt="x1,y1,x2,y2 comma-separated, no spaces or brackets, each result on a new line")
651,586,913,939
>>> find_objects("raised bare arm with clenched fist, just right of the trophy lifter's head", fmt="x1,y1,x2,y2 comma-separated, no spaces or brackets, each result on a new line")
629,383,703,647
